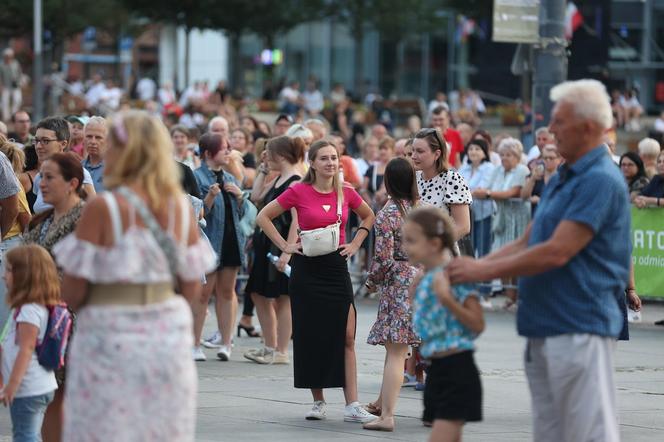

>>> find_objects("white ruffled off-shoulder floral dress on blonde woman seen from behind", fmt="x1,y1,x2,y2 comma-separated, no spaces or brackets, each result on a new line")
54,192,217,442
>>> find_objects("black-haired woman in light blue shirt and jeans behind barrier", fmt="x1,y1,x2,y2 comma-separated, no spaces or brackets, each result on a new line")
459,139,496,258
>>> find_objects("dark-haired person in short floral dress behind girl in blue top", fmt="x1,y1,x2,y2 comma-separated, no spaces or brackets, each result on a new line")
364,158,419,431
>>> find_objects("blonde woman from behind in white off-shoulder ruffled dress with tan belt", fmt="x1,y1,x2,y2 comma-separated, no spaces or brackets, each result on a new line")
54,111,216,441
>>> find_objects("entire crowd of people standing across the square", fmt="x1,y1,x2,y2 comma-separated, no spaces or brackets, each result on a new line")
0,76,664,441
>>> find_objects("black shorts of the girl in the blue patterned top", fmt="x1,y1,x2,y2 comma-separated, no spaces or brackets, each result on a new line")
422,351,482,422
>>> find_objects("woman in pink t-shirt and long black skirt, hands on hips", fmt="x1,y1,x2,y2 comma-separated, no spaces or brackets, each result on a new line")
256,140,375,422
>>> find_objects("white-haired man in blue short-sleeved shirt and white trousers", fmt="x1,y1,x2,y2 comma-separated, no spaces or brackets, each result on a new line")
449,80,631,442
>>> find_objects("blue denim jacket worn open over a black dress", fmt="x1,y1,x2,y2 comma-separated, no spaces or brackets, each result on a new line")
194,163,246,266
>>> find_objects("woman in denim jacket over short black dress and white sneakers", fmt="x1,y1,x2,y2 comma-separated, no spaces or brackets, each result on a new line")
193,133,246,361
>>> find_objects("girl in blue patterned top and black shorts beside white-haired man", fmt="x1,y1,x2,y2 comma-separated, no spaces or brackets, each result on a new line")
403,207,484,441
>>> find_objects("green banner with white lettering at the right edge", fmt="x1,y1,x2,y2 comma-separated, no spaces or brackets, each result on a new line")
632,207,664,299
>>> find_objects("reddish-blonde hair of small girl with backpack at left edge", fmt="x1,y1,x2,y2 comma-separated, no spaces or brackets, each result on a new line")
5,244,60,308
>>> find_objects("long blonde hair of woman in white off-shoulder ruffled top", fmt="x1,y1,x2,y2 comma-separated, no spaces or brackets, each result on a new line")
104,110,182,209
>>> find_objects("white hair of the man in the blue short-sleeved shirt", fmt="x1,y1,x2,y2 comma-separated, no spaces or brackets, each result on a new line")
549,80,613,129
